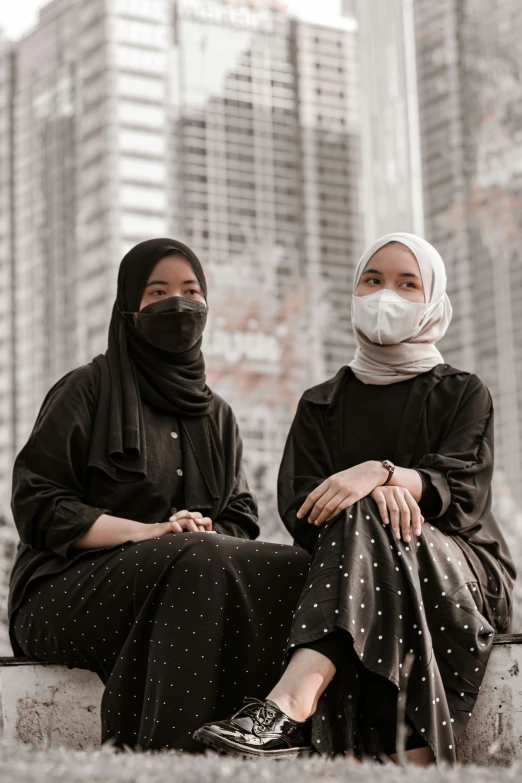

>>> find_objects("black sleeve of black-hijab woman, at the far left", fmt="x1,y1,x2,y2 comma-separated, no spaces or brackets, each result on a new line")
11,367,111,558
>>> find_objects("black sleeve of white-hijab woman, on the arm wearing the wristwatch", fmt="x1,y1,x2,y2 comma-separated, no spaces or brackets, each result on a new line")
411,374,494,537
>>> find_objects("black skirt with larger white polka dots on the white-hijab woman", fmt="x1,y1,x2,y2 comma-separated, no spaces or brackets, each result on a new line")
286,496,508,763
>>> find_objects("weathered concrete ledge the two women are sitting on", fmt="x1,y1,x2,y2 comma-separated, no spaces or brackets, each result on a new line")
0,634,522,765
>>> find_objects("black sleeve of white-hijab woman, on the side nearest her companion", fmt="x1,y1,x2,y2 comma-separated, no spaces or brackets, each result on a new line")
277,399,335,553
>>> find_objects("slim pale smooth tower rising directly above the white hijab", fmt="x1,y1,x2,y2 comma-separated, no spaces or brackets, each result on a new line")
354,0,424,244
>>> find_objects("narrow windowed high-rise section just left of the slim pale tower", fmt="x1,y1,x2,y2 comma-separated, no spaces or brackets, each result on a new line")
294,13,363,382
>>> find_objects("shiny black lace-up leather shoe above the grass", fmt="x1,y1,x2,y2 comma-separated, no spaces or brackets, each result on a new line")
193,698,314,758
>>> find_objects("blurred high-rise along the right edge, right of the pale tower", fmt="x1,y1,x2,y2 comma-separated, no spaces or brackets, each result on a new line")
414,0,522,508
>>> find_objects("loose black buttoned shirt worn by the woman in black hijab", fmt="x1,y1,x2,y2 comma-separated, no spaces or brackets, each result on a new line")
8,357,259,632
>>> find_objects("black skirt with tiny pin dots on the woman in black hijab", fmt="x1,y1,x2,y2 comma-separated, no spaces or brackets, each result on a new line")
10,533,310,752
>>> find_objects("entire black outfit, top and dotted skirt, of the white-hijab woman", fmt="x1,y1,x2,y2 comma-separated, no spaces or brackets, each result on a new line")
278,364,516,762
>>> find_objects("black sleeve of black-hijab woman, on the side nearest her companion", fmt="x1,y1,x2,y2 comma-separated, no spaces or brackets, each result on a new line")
212,406,260,539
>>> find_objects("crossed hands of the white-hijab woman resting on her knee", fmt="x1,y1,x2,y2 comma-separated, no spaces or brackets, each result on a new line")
297,462,424,542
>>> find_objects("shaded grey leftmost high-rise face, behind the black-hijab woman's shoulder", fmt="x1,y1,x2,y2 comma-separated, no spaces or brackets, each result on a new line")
13,0,81,460
